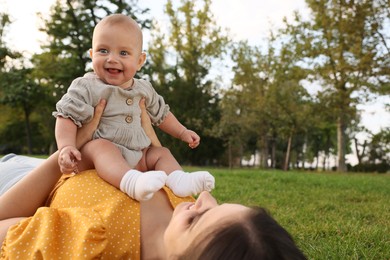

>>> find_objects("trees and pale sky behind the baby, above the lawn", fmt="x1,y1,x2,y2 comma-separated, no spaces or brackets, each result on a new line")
0,0,390,172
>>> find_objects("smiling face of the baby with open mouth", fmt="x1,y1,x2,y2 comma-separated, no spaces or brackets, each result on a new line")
91,22,145,89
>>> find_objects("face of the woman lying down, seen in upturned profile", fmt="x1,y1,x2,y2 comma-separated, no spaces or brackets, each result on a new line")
164,192,250,256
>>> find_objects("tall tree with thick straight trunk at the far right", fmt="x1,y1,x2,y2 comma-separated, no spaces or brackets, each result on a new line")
285,0,390,171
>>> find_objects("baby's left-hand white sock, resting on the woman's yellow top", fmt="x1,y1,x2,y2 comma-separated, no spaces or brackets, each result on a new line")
120,170,167,201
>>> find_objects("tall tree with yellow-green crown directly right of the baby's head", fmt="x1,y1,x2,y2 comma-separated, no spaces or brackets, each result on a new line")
144,0,227,165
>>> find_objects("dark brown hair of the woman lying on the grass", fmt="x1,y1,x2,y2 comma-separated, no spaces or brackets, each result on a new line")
179,207,306,260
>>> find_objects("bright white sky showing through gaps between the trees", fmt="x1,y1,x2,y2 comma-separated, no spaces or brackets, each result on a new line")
0,0,390,162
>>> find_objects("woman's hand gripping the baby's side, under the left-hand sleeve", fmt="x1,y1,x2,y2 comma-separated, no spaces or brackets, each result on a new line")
76,99,106,148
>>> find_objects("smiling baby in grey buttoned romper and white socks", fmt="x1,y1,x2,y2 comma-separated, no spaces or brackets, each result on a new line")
53,14,215,200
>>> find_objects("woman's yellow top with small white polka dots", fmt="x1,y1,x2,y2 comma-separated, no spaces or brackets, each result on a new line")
1,170,193,260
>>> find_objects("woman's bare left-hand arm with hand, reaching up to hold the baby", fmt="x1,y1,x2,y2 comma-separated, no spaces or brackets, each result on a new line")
0,100,106,220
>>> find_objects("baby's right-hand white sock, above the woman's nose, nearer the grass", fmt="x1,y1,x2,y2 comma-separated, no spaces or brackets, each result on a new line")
166,170,215,197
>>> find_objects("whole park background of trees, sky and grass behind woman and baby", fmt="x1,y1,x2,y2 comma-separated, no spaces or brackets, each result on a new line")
0,0,390,259
